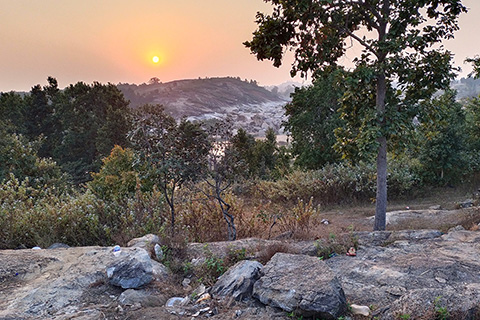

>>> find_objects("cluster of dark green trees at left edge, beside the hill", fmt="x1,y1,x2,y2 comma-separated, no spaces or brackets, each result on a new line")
0,78,130,184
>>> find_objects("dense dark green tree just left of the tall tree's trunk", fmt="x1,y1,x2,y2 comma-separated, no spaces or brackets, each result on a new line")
284,70,344,169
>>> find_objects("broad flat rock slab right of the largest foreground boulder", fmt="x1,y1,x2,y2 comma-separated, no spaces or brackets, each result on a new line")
326,231,480,319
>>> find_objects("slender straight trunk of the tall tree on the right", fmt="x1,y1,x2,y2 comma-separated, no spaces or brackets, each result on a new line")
373,72,387,231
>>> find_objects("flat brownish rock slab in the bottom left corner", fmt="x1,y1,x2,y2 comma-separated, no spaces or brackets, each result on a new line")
0,247,165,319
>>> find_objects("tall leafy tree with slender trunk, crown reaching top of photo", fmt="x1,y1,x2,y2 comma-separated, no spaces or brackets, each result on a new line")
245,0,466,230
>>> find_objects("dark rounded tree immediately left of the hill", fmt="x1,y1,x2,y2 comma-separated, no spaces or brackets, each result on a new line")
53,82,130,184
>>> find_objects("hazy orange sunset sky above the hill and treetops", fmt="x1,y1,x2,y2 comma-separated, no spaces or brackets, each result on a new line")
0,0,480,92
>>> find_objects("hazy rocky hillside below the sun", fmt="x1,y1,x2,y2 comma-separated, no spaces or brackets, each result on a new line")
118,77,288,136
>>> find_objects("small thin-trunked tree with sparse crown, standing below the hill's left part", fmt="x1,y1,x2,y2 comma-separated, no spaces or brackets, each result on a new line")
129,105,209,235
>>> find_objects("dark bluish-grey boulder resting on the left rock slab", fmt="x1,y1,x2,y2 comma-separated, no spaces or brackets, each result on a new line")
107,248,154,289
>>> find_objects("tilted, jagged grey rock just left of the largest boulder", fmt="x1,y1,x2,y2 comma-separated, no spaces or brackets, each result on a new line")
211,260,263,300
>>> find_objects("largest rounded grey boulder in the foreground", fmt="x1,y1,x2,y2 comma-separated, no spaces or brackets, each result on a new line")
253,253,347,319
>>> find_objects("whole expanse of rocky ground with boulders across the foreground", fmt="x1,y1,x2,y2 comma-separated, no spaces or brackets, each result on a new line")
0,208,480,320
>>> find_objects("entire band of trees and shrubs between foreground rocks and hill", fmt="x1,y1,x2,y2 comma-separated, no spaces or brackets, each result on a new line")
0,75,480,248
